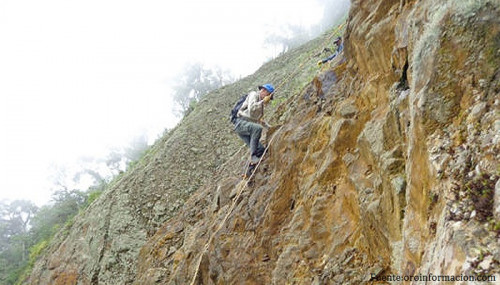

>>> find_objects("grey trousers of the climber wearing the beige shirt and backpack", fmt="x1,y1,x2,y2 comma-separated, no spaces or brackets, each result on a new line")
234,119,266,163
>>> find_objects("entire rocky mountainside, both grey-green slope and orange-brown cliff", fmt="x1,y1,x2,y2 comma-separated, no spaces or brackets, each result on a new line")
26,0,500,284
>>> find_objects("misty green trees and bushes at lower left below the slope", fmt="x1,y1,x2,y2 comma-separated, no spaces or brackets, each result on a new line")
0,130,153,285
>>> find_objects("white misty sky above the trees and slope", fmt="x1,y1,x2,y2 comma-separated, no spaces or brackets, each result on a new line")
0,0,345,205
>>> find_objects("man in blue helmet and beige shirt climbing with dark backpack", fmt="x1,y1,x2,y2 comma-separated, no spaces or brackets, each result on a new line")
231,84,274,177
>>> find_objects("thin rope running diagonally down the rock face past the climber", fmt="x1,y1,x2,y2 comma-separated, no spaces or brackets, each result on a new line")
190,22,345,285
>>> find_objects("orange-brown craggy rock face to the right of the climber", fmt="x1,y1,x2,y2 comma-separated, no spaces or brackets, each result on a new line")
135,0,500,284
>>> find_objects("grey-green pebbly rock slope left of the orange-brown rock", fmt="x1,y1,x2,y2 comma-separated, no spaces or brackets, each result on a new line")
24,23,325,284
